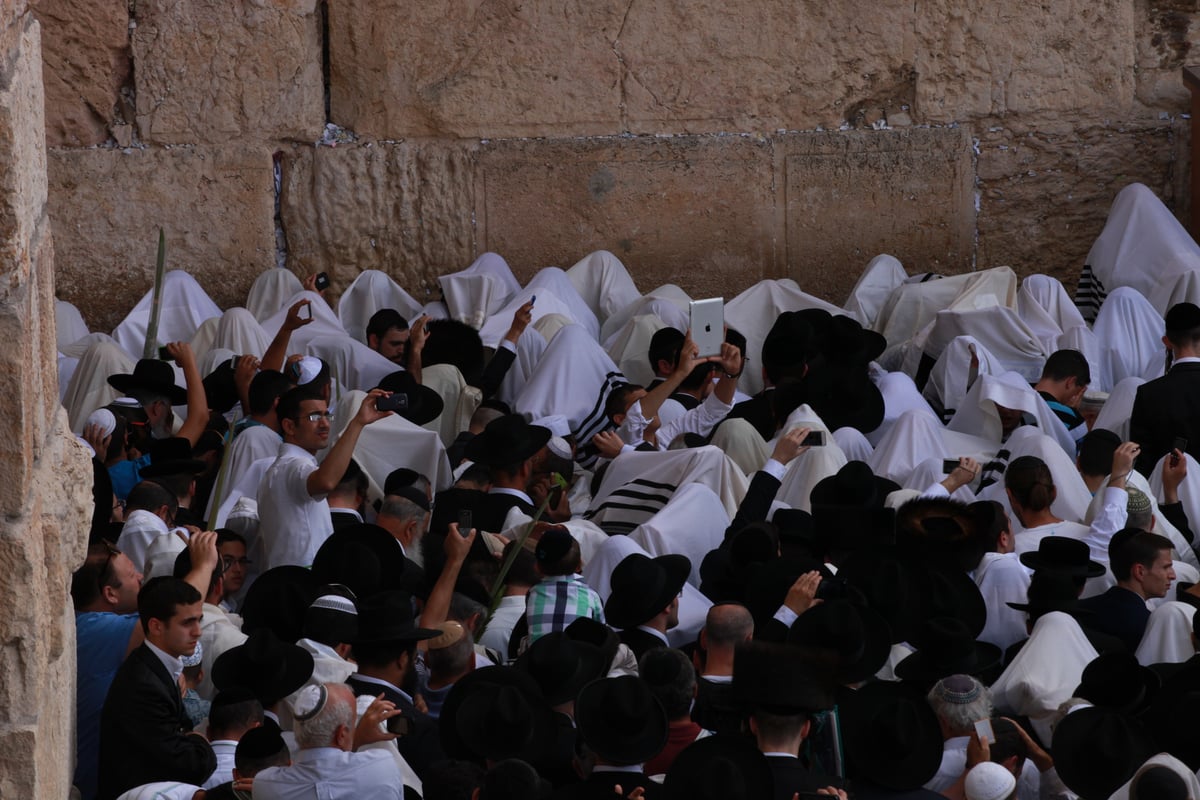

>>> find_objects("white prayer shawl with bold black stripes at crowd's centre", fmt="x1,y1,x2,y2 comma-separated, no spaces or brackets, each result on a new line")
583,446,749,533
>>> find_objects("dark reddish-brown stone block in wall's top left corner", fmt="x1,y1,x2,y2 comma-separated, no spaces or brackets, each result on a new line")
34,0,132,148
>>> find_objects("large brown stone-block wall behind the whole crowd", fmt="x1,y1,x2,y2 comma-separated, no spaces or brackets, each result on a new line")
35,0,1200,329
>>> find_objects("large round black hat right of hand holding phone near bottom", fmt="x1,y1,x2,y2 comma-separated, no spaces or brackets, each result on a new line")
438,666,557,763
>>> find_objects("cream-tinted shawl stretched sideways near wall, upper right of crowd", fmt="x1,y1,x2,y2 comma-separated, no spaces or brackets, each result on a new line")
875,266,1016,347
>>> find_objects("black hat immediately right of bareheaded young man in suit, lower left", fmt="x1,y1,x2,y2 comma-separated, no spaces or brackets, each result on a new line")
212,628,313,708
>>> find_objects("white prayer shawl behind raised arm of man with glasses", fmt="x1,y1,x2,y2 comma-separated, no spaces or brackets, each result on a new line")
331,391,454,500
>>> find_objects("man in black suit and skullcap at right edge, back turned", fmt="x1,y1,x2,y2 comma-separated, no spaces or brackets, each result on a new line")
1129,302,1200,475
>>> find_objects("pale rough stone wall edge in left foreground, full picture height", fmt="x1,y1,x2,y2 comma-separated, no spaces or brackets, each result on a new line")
0,2,91,798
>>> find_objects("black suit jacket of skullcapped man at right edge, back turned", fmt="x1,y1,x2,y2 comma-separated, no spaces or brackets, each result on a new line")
1129,363,1200,475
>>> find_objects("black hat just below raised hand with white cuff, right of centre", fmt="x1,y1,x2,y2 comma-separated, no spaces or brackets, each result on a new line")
787,600,892,684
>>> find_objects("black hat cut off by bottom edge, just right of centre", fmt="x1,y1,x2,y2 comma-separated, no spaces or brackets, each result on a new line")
662,734,775,800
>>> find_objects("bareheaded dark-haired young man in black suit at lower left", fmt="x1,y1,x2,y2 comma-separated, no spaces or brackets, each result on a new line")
97,577,217,800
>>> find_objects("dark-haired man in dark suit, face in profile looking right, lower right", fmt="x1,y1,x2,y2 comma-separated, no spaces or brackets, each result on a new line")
1079,528,1175,652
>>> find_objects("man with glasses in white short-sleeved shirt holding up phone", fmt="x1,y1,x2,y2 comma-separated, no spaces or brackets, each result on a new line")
258,387,391,570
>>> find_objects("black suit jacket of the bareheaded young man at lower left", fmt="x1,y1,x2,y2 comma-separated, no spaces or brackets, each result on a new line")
96,644,217,800
